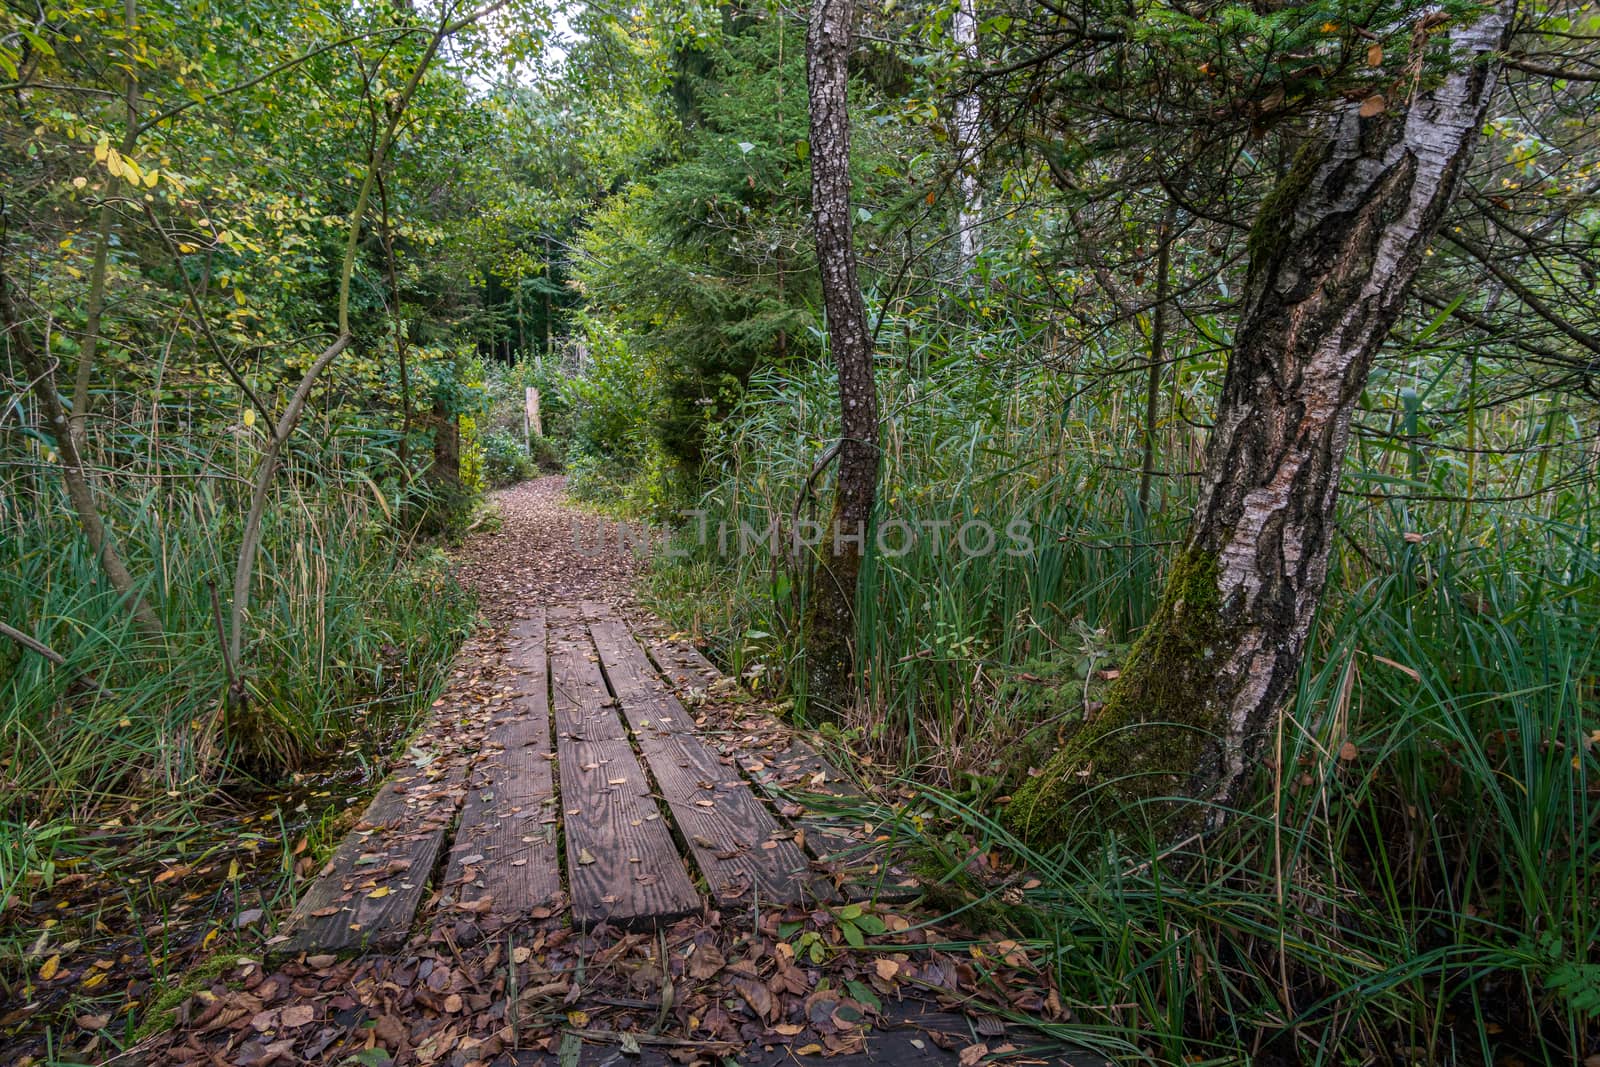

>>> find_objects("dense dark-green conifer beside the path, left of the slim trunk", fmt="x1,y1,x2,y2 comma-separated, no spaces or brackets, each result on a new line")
579,10,816,469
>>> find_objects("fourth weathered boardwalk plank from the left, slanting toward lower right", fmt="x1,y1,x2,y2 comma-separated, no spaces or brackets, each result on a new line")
589,619,837,904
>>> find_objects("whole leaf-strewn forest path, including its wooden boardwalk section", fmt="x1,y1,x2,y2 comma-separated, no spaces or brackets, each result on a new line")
118,478,1104,1067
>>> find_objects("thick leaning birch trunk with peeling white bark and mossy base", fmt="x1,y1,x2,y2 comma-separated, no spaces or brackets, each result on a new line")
1006,2,1510,841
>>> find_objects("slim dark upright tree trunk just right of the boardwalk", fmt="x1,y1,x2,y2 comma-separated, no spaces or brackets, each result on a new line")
805,0,878,715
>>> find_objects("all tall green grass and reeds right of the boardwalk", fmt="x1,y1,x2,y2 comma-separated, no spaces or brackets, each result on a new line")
582,327,1600,1064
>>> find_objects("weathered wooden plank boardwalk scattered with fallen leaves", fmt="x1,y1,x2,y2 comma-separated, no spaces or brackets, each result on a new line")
277,603,876,953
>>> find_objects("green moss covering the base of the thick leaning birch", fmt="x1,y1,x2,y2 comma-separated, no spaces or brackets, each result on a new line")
1005,549,1229,845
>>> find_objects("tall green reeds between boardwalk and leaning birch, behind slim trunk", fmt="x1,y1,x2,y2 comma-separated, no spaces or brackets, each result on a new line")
651,360,1189,782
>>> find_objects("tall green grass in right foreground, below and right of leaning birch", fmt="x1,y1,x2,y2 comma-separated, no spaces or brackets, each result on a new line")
861,528,1600,1064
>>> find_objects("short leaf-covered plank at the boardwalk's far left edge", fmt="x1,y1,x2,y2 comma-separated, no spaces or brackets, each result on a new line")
272,765,462,955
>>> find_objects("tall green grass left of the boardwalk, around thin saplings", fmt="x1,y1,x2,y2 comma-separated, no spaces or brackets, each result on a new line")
0,419,472,899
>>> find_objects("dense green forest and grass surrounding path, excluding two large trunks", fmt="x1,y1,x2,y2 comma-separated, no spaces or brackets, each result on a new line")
0,0,1600,1062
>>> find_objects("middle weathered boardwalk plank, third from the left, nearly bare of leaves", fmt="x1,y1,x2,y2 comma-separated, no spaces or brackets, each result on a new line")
549,608,701,926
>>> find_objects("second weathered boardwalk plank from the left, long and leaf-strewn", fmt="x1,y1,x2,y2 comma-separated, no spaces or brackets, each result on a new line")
442,611,562,921
